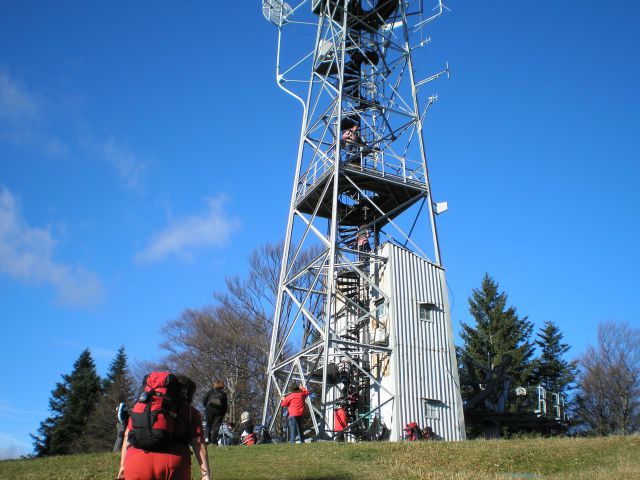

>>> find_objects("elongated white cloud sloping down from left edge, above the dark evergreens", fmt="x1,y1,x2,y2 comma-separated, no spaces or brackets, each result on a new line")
0,186,104,307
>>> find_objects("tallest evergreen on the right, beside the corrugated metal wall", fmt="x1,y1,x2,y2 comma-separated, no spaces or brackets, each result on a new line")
458,274,533,398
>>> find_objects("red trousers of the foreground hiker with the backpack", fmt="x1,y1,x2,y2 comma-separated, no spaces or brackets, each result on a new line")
124,449,191,480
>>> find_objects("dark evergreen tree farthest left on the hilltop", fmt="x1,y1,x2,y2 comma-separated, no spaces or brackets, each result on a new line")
32,349,100,456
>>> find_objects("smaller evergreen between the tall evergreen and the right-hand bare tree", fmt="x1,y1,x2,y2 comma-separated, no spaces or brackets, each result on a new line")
533,321,577,395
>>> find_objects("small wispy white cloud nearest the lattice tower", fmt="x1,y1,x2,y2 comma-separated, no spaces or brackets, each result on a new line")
135,196,240,263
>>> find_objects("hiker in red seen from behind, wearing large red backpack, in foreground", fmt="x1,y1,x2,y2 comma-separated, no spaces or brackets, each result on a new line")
118,372,210,480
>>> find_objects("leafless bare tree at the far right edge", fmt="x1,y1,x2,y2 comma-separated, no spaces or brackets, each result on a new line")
576,321,640,435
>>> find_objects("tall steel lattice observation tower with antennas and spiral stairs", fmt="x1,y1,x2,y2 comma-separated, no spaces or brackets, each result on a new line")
262,0,465,440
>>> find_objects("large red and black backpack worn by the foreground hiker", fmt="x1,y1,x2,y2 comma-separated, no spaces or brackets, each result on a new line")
129,372,188,450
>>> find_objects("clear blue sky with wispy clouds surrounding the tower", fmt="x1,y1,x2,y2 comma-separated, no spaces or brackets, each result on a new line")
0,0,640,457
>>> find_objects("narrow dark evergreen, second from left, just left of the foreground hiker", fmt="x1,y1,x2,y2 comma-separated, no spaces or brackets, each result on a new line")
74,347,133,452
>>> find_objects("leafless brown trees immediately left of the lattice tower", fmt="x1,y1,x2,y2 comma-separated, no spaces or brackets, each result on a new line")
156,242,322,420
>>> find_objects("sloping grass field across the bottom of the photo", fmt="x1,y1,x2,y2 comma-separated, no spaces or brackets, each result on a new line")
0,435,640,480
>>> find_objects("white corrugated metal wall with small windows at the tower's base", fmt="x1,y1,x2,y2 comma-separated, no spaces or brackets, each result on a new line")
381,244,465,440
